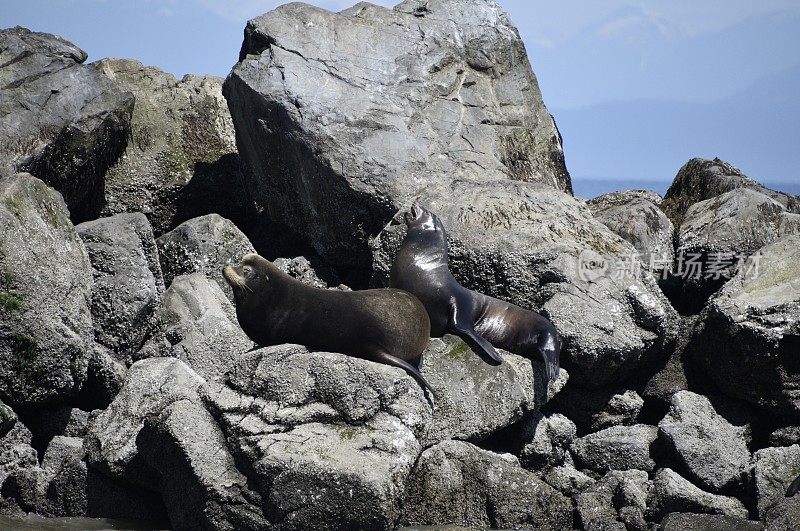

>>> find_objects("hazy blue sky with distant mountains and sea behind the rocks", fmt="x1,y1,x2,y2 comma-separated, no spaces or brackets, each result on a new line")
0,0,800,197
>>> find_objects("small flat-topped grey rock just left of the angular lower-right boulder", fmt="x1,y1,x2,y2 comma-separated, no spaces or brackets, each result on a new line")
571,424,658,472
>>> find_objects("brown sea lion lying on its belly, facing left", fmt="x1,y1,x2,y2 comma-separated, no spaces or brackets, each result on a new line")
222,254,433,393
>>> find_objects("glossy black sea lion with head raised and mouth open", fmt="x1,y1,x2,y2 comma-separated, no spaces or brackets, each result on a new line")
389,205,561,380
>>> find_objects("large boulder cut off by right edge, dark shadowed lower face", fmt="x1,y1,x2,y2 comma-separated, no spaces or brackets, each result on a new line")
687,235,800,417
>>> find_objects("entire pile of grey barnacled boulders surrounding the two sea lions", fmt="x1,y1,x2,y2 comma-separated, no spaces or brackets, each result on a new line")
0,0,800,531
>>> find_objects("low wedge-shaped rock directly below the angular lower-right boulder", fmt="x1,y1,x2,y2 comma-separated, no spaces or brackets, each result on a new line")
647,468,747,520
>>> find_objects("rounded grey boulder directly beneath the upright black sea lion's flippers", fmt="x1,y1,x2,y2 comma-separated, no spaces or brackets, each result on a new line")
421,335,567,446
